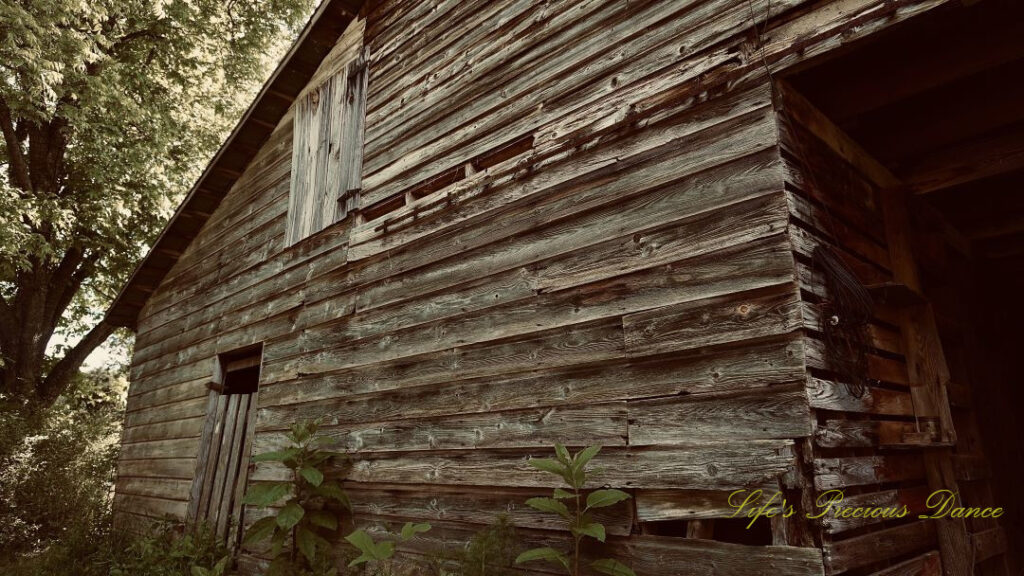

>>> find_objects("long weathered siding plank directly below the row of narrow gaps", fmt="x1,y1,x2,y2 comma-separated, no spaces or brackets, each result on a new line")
350,92,777,263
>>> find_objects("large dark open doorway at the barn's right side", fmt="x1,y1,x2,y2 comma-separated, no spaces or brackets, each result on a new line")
778,0,1024,575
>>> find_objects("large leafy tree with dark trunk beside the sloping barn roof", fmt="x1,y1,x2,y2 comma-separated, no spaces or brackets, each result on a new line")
0,0,310,405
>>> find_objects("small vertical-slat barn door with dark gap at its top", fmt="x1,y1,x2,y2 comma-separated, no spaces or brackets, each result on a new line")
188,342,262,546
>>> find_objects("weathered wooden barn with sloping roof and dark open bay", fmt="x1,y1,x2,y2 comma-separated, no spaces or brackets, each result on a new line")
109,0,1024,576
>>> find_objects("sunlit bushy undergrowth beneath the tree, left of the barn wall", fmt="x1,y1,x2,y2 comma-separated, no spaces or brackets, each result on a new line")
0,362,127,561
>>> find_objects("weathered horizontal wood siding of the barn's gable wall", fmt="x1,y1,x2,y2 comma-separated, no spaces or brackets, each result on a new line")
117,0,958,575
